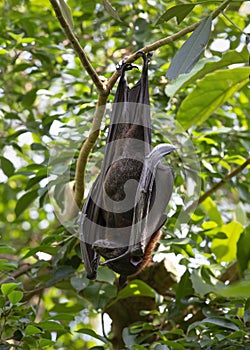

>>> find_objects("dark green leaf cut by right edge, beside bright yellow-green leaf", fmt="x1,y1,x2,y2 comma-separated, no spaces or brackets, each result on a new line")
237,226,250,273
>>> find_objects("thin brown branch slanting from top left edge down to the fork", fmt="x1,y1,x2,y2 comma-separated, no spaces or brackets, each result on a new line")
50,0,109,95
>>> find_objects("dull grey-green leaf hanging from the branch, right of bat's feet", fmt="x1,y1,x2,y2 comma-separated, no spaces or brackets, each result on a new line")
167,17,212,80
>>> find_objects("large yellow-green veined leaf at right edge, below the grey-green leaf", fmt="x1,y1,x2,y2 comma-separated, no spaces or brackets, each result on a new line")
176,67,250,129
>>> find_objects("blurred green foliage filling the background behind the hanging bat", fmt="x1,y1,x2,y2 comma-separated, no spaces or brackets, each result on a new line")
0,0,250,350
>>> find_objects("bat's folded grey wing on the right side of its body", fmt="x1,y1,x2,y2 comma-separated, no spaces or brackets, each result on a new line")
129,144,175,256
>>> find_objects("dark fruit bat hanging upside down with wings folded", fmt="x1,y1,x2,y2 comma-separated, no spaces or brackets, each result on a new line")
78,52,175,279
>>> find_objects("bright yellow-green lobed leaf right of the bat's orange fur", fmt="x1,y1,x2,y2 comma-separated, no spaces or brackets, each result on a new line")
211,221,243,262
